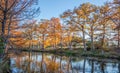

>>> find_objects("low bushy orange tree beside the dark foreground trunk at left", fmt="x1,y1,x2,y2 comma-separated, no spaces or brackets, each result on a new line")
7,25,26,48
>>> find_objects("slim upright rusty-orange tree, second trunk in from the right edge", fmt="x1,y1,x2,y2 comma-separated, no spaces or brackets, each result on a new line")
99,3,110,49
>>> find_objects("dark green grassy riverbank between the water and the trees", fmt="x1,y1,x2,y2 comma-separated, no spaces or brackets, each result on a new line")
8,49,120,60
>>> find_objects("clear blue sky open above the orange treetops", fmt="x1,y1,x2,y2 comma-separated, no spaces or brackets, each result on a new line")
39,0,112,19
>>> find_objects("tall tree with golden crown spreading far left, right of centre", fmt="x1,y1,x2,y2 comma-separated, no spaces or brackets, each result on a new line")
61,3,96,50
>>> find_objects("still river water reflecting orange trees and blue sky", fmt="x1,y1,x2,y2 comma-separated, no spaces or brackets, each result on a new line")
10,52,120,73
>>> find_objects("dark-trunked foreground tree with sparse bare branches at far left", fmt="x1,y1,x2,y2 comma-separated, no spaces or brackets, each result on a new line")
0,0,39,53
